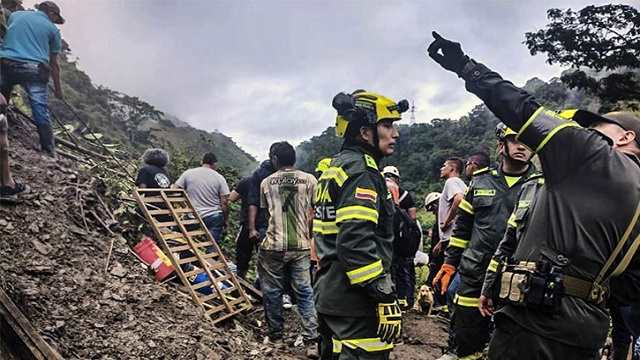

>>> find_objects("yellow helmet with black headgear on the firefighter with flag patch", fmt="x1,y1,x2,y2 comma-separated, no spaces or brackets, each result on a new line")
332,90,409,137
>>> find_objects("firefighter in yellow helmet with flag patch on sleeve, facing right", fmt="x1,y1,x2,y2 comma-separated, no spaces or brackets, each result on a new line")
313,90,409,360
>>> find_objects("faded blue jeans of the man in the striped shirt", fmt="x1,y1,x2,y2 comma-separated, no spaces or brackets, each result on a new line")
258,249,318,341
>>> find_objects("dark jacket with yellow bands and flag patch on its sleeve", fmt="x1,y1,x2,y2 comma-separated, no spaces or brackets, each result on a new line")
313,145,394,317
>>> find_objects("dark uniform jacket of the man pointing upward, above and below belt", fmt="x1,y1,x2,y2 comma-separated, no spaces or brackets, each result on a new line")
461,61,640,349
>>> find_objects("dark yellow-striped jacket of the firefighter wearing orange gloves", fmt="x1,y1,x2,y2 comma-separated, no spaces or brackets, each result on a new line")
445,165,535,308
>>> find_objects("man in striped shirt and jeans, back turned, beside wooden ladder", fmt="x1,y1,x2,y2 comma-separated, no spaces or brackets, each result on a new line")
258,141,318,357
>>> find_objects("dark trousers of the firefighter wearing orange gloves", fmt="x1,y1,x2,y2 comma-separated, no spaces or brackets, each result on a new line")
451,305,491,357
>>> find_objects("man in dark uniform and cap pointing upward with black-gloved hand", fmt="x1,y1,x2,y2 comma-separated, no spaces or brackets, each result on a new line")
428,32,640,360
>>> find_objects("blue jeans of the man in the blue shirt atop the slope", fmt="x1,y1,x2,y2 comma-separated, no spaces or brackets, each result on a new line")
0,62,50,125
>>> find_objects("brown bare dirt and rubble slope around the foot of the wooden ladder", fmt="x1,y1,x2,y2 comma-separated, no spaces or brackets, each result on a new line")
0,125,445,359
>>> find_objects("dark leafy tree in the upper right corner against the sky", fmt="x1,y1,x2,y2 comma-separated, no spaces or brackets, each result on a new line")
525,4,640,110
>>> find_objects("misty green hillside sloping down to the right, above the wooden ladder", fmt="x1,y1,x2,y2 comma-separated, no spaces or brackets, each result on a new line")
21,55,256,173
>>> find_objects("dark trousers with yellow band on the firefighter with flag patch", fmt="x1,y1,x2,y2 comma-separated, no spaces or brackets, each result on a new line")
318,313,393,360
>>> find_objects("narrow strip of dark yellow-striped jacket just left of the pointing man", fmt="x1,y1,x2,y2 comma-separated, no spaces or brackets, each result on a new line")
482,173,544,298
